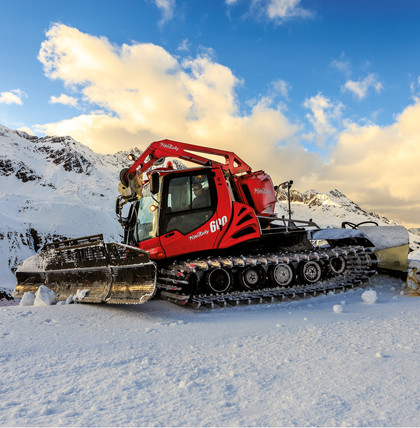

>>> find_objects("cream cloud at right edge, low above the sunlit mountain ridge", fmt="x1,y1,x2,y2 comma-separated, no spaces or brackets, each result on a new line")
298,101,420,227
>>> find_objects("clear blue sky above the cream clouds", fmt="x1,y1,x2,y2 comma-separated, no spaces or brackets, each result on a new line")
0,0,420,130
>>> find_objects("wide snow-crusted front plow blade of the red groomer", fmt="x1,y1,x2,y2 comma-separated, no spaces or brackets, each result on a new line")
14,235,156,303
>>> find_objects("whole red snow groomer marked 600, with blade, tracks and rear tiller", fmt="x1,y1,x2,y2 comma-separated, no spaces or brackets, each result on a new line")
16,140,408,307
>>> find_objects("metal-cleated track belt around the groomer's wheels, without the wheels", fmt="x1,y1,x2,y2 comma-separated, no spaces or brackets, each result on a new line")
158,247,376,309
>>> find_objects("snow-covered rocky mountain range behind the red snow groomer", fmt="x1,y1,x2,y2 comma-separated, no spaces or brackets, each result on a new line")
0,125,420,291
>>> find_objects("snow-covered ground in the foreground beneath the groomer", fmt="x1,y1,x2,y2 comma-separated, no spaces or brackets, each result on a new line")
0,276,420,426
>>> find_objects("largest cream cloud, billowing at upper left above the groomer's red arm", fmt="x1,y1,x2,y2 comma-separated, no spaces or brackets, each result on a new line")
37,24,298,172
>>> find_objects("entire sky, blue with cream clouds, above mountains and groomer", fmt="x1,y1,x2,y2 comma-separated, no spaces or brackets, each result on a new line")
0,0,420,227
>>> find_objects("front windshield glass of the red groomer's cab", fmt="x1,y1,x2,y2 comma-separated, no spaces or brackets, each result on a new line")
133,186,158,242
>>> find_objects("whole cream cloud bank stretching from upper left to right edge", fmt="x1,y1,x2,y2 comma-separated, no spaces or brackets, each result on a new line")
35,24,420,224
